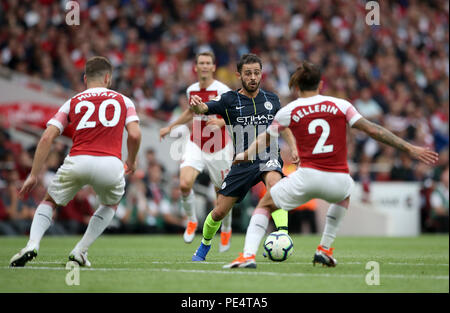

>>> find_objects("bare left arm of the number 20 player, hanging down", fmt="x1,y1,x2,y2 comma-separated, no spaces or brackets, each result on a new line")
19,125,59,198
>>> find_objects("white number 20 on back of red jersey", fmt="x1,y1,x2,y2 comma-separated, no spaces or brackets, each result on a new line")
75,99,120,130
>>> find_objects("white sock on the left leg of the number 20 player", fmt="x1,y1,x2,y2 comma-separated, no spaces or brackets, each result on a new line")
27,202,53,250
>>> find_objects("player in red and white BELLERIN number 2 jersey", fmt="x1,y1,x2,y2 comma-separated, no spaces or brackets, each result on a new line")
230,61,438,267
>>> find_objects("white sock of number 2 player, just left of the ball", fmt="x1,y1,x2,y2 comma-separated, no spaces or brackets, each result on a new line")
244,209,269,257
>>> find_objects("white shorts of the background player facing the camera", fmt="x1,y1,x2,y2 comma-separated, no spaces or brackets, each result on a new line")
180,140,234,189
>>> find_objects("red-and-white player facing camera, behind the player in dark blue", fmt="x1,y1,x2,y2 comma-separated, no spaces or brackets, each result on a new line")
160,52,233,252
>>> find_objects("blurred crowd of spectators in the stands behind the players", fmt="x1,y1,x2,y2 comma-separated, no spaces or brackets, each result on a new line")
0,0,449,231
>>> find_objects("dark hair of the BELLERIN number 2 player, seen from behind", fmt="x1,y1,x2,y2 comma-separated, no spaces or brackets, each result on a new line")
289,61,322,91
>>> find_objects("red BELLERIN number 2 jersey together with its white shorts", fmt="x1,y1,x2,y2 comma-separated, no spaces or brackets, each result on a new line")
267,95,361,210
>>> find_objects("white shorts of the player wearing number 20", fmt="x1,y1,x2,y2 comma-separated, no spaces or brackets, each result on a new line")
48,155,125,206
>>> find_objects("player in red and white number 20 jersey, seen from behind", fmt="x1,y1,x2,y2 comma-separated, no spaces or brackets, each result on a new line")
10,56,141,267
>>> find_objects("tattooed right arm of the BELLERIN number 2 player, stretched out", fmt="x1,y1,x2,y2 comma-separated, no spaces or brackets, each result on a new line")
352,118,439,164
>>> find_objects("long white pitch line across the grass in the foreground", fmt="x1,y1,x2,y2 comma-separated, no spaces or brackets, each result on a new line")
2,266,449,280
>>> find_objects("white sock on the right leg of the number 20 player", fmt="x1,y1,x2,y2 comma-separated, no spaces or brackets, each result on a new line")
75,204,115,252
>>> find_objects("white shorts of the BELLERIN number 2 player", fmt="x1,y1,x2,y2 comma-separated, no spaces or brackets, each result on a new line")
270,167,355,211
